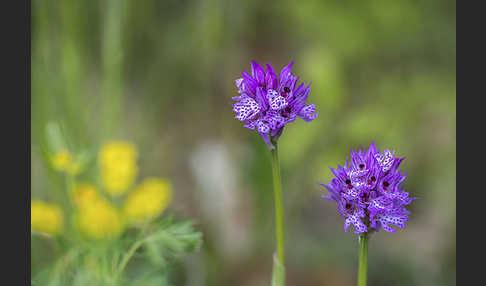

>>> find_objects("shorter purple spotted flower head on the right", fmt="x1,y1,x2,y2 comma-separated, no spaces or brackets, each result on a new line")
321,142,415,234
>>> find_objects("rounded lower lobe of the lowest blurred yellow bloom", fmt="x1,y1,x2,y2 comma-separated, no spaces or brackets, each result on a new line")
74,198,124,239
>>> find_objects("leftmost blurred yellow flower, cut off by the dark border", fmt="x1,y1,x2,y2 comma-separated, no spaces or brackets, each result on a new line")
31,200,63,235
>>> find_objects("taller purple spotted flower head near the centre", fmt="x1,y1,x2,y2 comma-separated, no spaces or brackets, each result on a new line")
233,61,318,148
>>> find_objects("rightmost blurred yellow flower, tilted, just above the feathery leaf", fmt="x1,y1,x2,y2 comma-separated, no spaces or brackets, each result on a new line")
123,178,172,221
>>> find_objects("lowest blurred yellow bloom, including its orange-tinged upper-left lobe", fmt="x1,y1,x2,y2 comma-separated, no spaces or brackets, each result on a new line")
72,184,124,239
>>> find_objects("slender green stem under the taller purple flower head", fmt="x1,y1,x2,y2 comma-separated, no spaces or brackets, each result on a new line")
272,143,285,266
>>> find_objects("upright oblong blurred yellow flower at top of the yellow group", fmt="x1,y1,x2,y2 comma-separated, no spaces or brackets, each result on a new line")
99,141,138,196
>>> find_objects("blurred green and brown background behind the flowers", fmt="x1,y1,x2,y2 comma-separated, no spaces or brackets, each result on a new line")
32,0,456,286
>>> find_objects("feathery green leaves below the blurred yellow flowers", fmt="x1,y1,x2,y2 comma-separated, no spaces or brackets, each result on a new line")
32,216,202,286
